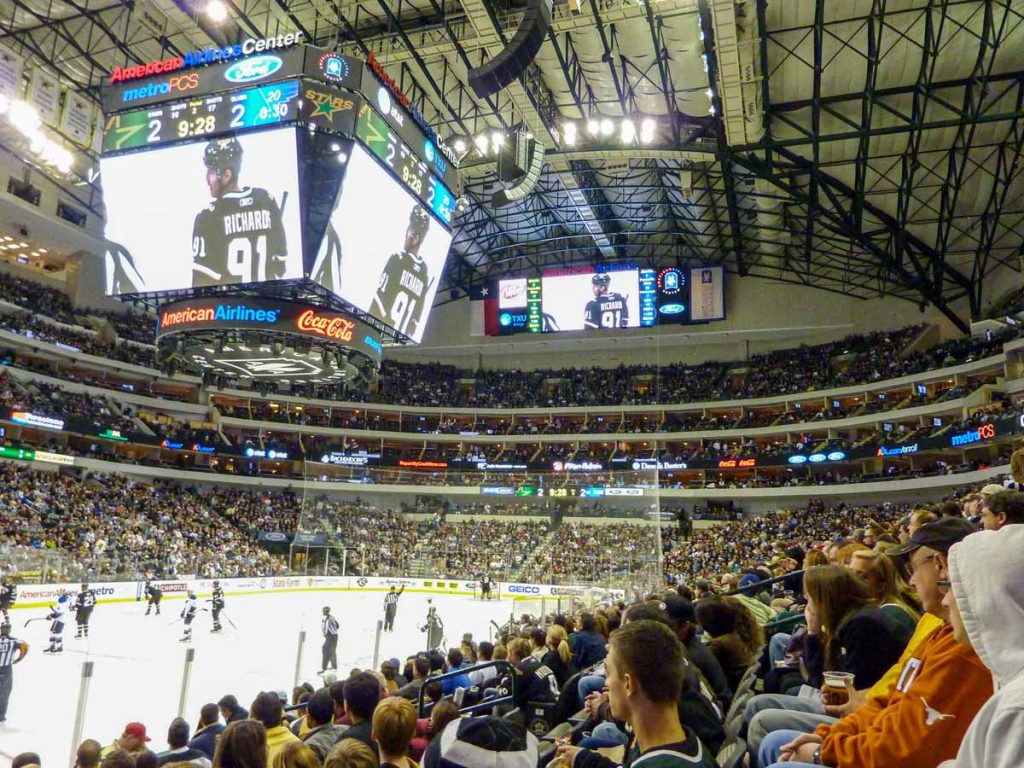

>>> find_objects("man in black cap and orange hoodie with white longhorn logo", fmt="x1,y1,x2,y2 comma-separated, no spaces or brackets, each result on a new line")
758,517,992,768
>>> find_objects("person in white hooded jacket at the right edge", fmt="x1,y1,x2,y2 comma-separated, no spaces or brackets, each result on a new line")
939,525,1024,768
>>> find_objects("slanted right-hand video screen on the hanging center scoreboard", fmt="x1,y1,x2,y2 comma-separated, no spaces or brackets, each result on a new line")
310,144,452,342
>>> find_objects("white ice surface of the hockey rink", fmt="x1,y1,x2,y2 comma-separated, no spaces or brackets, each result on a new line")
0,591,512,768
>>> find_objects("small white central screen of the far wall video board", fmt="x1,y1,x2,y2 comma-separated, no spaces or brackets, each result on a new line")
541,269,640,333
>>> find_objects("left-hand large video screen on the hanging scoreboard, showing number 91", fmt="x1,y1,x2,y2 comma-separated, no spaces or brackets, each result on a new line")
100,128,302,294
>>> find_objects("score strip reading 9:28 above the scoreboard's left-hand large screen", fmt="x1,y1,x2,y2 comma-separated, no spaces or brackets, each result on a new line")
103,80,299,153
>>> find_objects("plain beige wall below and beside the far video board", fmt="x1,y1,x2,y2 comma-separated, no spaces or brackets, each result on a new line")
388,274,955,370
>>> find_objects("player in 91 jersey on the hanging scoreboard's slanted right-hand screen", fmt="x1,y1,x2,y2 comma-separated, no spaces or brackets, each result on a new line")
372,206,431,336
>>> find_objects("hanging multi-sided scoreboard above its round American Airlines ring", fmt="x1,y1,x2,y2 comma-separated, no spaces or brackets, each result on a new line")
100,35,460,341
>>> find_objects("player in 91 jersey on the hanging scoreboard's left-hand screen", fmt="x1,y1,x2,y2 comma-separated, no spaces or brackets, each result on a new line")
193,138,288,288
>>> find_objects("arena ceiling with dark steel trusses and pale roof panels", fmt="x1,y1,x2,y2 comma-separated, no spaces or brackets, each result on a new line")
0,0,1024,327
